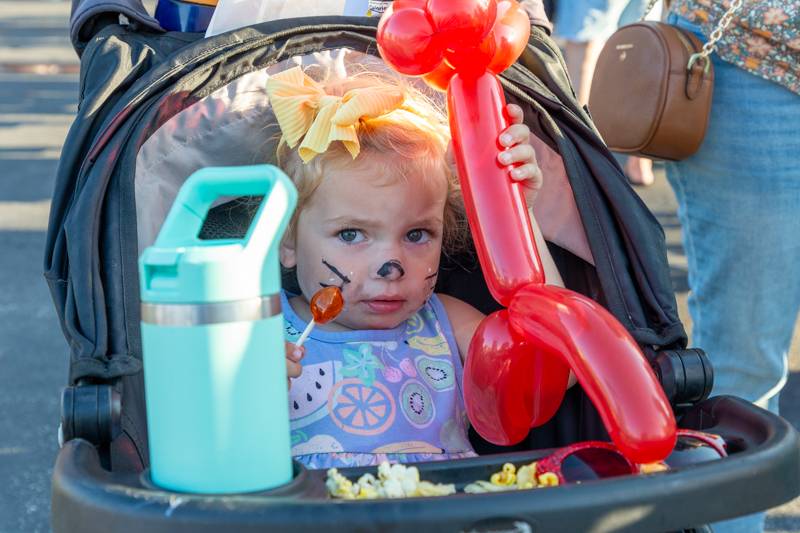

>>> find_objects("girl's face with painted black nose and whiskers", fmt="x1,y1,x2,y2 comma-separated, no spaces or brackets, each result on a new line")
281,156,447,329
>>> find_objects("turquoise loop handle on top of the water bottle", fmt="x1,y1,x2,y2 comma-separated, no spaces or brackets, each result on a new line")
155,165,297,254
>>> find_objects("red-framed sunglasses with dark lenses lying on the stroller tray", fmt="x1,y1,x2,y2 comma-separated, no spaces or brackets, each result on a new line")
536,429,728,483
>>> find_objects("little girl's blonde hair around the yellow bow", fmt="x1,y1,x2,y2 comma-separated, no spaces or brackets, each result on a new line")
276,73,469,254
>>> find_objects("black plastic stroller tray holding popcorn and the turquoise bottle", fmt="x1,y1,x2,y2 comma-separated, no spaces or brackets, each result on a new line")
52,396,800,533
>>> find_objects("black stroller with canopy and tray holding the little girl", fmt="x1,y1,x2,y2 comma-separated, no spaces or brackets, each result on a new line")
45,0,800,533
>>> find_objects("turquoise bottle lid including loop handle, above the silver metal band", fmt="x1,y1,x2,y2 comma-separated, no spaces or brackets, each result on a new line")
139,165,297,304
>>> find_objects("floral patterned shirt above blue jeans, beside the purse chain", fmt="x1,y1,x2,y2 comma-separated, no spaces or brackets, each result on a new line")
670,0,800,94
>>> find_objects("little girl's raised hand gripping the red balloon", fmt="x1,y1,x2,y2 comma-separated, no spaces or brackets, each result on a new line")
497,104,542,207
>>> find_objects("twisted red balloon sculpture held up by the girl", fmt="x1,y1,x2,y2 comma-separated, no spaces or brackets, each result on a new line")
378,0,676,463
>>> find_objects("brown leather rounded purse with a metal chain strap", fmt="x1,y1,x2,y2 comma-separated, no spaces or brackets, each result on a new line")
589,0,742,161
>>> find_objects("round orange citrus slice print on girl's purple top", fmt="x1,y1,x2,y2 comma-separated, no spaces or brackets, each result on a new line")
328,378,395,435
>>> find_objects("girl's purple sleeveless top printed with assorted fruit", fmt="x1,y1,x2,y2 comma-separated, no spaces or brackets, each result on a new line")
281,293,476,468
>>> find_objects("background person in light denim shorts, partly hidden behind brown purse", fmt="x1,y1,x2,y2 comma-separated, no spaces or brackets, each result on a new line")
555,0,660,185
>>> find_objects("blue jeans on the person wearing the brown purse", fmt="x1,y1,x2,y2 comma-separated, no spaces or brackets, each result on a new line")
667,15,800,533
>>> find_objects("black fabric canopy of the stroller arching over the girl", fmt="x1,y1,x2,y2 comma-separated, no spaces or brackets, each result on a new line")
45,8,686,381
